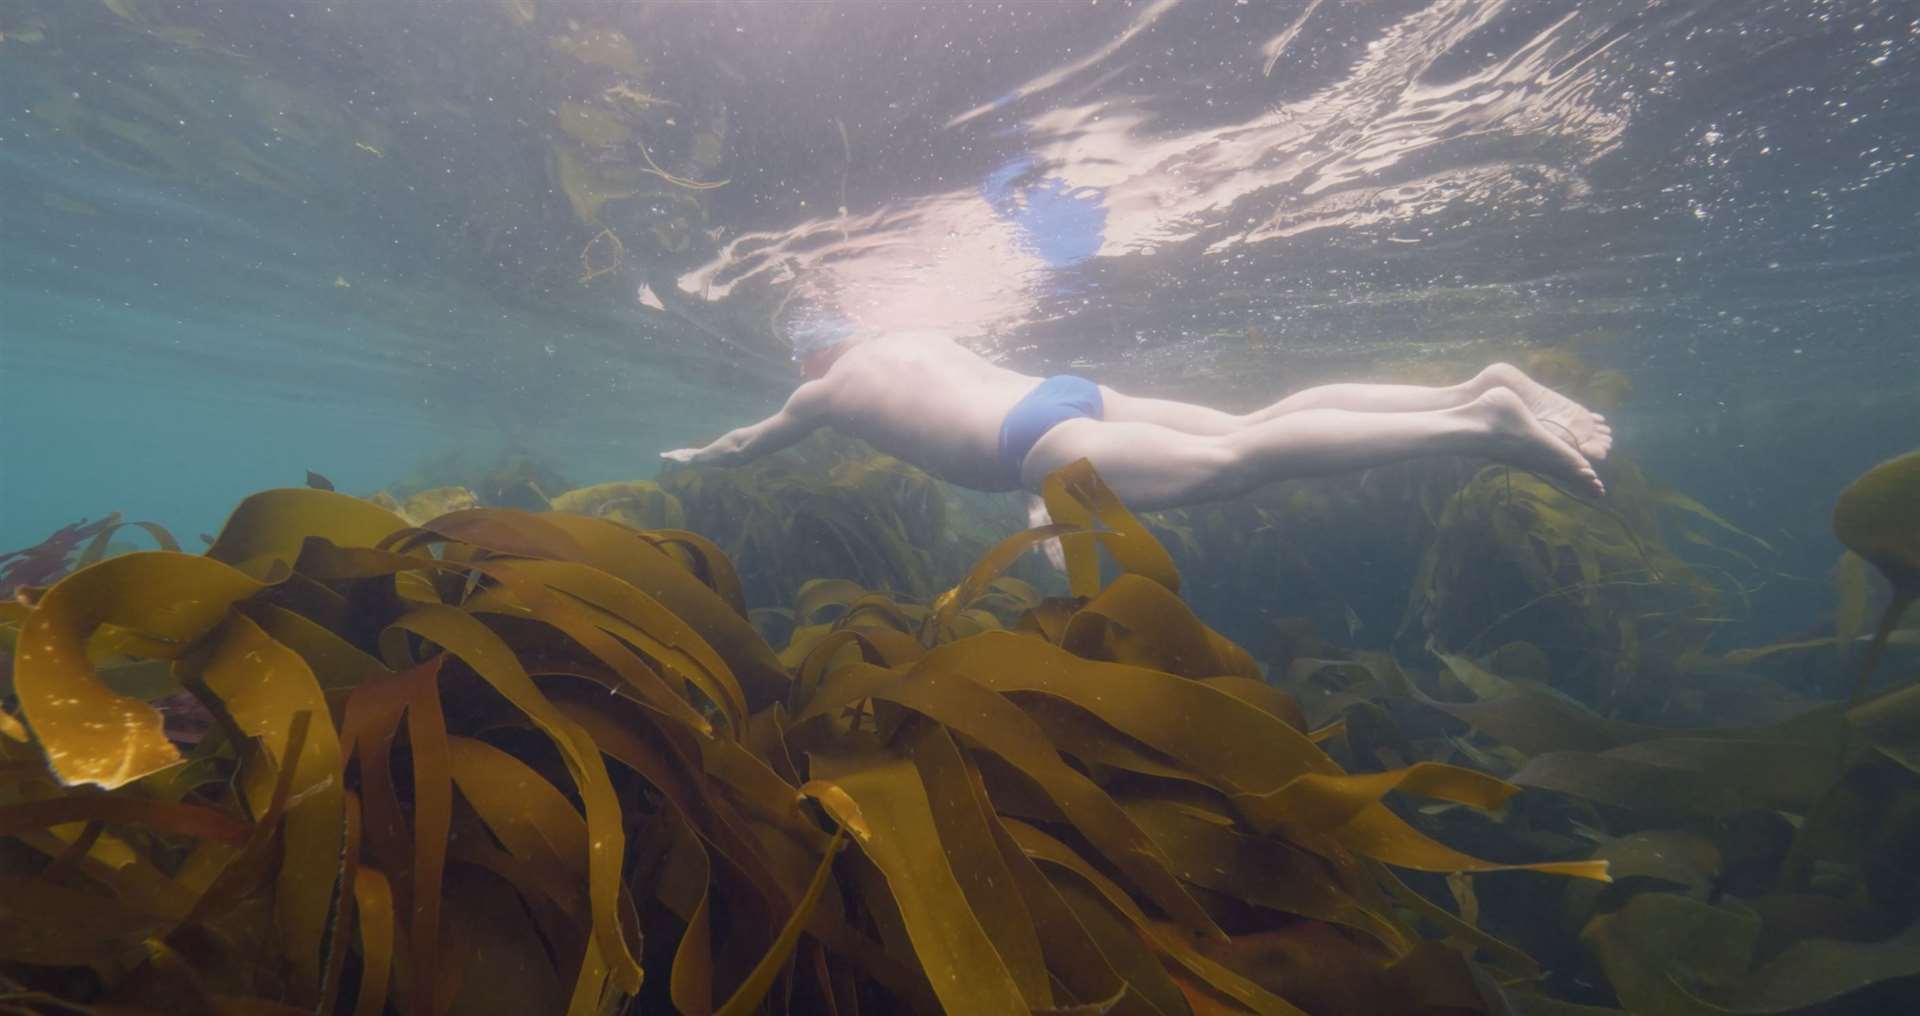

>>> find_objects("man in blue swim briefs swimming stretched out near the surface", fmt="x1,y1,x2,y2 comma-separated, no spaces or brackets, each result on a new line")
660,334,1613,511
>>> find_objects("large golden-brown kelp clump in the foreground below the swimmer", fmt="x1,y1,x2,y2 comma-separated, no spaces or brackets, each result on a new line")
0,461,1605,1014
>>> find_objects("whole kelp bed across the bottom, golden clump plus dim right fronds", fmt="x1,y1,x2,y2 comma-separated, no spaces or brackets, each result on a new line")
0,451,1920,1014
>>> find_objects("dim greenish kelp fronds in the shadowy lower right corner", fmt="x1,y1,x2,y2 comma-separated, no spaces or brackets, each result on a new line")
1259,651,1920,1014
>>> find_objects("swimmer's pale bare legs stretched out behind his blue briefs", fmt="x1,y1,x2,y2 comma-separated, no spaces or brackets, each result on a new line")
1021,388,1605,511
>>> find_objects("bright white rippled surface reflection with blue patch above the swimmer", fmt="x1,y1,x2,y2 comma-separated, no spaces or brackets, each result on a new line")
680,2,1638,353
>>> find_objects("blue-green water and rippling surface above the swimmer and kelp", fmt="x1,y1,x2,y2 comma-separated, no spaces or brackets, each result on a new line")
0,0,1920,628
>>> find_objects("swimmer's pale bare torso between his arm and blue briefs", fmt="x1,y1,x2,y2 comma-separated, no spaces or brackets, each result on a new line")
816,334,1039,490
